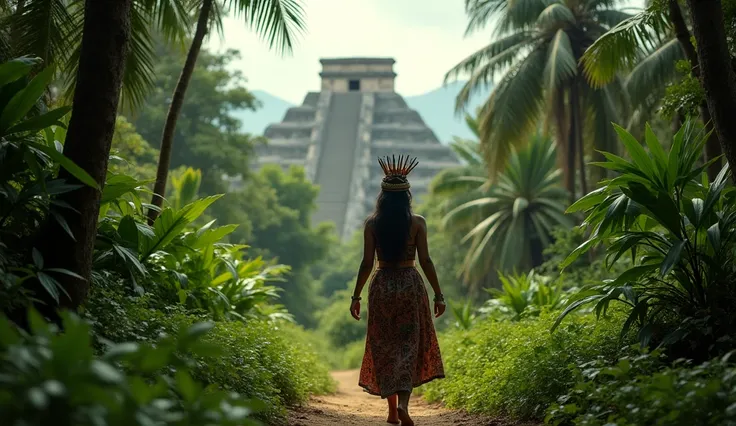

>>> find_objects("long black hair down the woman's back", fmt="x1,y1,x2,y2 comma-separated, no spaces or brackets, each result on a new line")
368,178,412,262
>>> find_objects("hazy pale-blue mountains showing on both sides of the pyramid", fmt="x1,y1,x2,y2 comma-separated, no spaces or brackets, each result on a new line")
233,82,490,143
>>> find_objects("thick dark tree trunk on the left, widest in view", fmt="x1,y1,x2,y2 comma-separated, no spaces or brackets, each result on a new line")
40,0,132,309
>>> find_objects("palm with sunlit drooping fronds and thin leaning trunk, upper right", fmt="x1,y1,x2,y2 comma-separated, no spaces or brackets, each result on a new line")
582,0,722,179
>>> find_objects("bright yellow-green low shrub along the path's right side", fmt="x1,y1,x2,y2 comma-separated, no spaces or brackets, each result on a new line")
422,313,620,418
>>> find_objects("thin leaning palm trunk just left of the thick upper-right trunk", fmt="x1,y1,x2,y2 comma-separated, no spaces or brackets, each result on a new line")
669,0,723,180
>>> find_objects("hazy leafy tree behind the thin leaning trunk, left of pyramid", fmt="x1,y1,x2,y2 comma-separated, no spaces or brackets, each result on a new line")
129,40,262,195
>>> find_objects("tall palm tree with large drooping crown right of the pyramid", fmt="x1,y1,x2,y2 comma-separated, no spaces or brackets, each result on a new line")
445,0,630,195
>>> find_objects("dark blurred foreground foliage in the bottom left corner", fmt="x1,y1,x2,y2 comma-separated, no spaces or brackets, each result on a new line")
0,313,256,426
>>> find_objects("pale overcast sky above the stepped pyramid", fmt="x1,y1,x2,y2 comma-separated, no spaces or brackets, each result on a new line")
208,0,490,104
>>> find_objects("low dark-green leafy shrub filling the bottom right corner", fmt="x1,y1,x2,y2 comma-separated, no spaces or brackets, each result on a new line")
546,352,736,426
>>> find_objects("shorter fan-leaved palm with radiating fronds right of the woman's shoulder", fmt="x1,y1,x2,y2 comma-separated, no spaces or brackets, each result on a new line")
432,134,572,278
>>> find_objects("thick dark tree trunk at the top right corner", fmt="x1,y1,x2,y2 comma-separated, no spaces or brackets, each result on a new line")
688,0,736,175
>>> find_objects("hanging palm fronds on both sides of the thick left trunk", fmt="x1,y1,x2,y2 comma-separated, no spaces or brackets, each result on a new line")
0,0,191,111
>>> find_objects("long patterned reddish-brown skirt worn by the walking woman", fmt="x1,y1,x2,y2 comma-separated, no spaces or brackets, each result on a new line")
359,268,445,398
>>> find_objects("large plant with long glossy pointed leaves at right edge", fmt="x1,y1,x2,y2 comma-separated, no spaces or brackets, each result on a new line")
557,122,736,359
